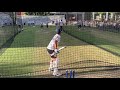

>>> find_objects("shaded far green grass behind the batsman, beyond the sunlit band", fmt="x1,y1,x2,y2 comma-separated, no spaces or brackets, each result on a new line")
1,26,120,49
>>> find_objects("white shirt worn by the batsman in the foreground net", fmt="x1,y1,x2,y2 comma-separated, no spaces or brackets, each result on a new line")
47,34,61,50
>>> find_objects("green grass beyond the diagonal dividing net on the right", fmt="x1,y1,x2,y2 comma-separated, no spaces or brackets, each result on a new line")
65,26,120,55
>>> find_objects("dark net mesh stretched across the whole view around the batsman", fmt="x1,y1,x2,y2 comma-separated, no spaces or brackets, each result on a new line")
0,12,120,78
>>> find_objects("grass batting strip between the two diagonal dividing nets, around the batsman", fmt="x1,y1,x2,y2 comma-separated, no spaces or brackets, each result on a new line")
0,26,120,77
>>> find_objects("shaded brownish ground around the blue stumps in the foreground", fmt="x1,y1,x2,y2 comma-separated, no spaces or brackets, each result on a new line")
31,66,120,78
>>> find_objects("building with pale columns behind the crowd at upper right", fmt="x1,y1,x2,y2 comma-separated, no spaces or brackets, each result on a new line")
50,12,120,21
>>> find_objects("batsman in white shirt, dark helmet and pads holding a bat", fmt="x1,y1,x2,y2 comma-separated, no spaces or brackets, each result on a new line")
47,28,62,76
